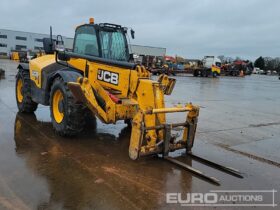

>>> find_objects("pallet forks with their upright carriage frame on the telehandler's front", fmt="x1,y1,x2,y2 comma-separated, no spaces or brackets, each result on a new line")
136,104,243,185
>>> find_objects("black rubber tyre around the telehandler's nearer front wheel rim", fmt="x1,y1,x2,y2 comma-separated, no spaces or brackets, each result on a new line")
50,78,87,136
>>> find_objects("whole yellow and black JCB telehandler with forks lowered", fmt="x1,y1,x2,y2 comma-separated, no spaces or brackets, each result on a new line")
16,18,243,183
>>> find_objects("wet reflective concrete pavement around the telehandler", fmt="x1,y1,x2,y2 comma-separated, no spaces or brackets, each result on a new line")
0,60,280,209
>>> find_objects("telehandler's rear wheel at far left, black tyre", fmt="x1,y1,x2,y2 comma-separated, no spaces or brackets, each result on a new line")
15,69,38,113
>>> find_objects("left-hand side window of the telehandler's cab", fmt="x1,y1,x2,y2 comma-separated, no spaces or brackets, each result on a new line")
73,26,99,56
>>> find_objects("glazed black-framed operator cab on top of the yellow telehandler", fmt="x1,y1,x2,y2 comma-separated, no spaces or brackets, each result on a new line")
73,22,134,62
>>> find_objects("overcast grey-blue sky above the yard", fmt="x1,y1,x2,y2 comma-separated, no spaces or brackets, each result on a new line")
0,0,280,59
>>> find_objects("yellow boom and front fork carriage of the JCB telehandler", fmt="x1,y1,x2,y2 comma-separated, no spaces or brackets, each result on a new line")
63,55,199,159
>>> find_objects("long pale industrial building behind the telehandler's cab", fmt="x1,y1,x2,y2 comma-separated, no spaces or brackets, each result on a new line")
0,29,166,58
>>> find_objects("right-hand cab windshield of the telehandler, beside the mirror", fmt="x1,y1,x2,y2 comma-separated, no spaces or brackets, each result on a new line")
99,30,128,61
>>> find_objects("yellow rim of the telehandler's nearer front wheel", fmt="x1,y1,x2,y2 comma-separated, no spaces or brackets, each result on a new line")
52,89,64,123
